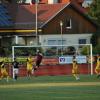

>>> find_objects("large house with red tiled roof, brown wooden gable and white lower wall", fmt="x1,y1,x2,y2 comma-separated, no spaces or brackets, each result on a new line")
0,0,97,46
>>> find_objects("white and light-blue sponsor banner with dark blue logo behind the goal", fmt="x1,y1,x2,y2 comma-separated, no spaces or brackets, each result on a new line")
59,56,87,64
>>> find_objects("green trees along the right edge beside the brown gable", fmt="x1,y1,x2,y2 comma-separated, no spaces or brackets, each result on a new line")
88,0,100,54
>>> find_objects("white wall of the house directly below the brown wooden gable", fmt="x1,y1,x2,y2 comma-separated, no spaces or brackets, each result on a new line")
39,34,92,45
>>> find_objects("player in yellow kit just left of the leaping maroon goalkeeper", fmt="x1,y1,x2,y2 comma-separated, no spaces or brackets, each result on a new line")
27,55,33,77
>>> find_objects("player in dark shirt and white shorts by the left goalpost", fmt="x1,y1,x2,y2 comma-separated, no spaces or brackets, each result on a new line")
12,58,19,80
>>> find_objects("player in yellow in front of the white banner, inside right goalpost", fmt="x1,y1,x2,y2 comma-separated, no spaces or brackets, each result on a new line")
72,60,80,80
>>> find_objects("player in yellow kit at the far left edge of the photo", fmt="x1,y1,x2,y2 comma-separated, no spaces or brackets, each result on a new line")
0,61,9,82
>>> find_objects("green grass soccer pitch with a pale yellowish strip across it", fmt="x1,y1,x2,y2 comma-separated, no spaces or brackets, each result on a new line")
0,75,100,100
